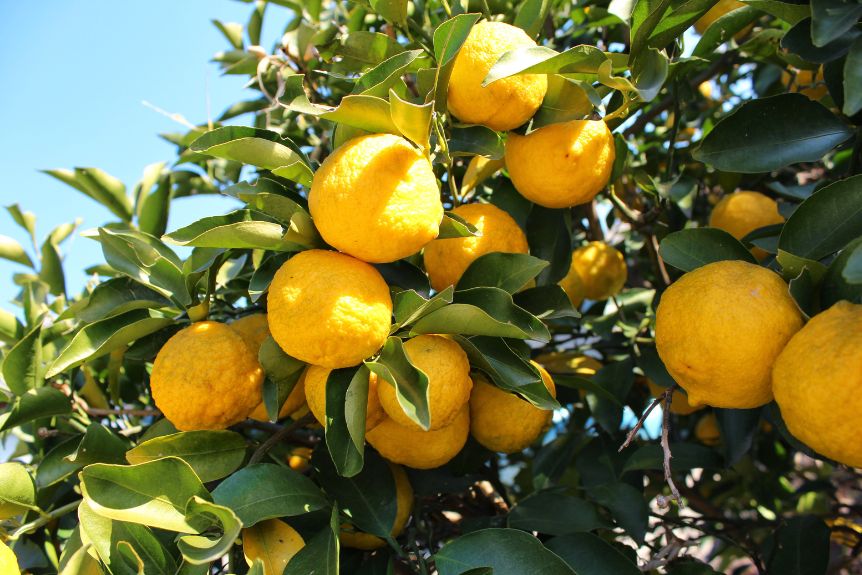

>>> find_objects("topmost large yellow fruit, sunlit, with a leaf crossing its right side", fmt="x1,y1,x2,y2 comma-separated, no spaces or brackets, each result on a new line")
448,22,548,131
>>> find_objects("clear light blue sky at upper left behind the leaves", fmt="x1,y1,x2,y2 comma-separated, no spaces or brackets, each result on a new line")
0,0,289,311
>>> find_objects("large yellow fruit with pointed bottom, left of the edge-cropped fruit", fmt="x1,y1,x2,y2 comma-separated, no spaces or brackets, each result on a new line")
655,261,802,409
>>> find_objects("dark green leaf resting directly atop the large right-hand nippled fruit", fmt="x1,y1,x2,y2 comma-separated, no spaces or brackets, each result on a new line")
659,228,757,272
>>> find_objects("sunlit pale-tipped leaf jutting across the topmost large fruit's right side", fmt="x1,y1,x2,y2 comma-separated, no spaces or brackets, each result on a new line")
482,45,622,86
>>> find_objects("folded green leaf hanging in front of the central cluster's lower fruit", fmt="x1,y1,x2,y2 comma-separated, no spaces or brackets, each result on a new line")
365,338,432,429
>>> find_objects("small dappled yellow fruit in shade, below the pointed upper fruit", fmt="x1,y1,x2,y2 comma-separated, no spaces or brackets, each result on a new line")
560,242,628,307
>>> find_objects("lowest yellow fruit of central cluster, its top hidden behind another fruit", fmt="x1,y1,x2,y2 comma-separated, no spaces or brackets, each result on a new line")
365,405,470,469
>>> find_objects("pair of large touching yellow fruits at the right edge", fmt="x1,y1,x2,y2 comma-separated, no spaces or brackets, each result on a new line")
655,261,862,467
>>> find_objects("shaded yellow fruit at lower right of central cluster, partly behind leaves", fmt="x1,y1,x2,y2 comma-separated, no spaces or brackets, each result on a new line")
470,362,557,453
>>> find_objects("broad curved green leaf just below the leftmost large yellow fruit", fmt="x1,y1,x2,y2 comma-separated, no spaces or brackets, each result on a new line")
126,430,246,483
